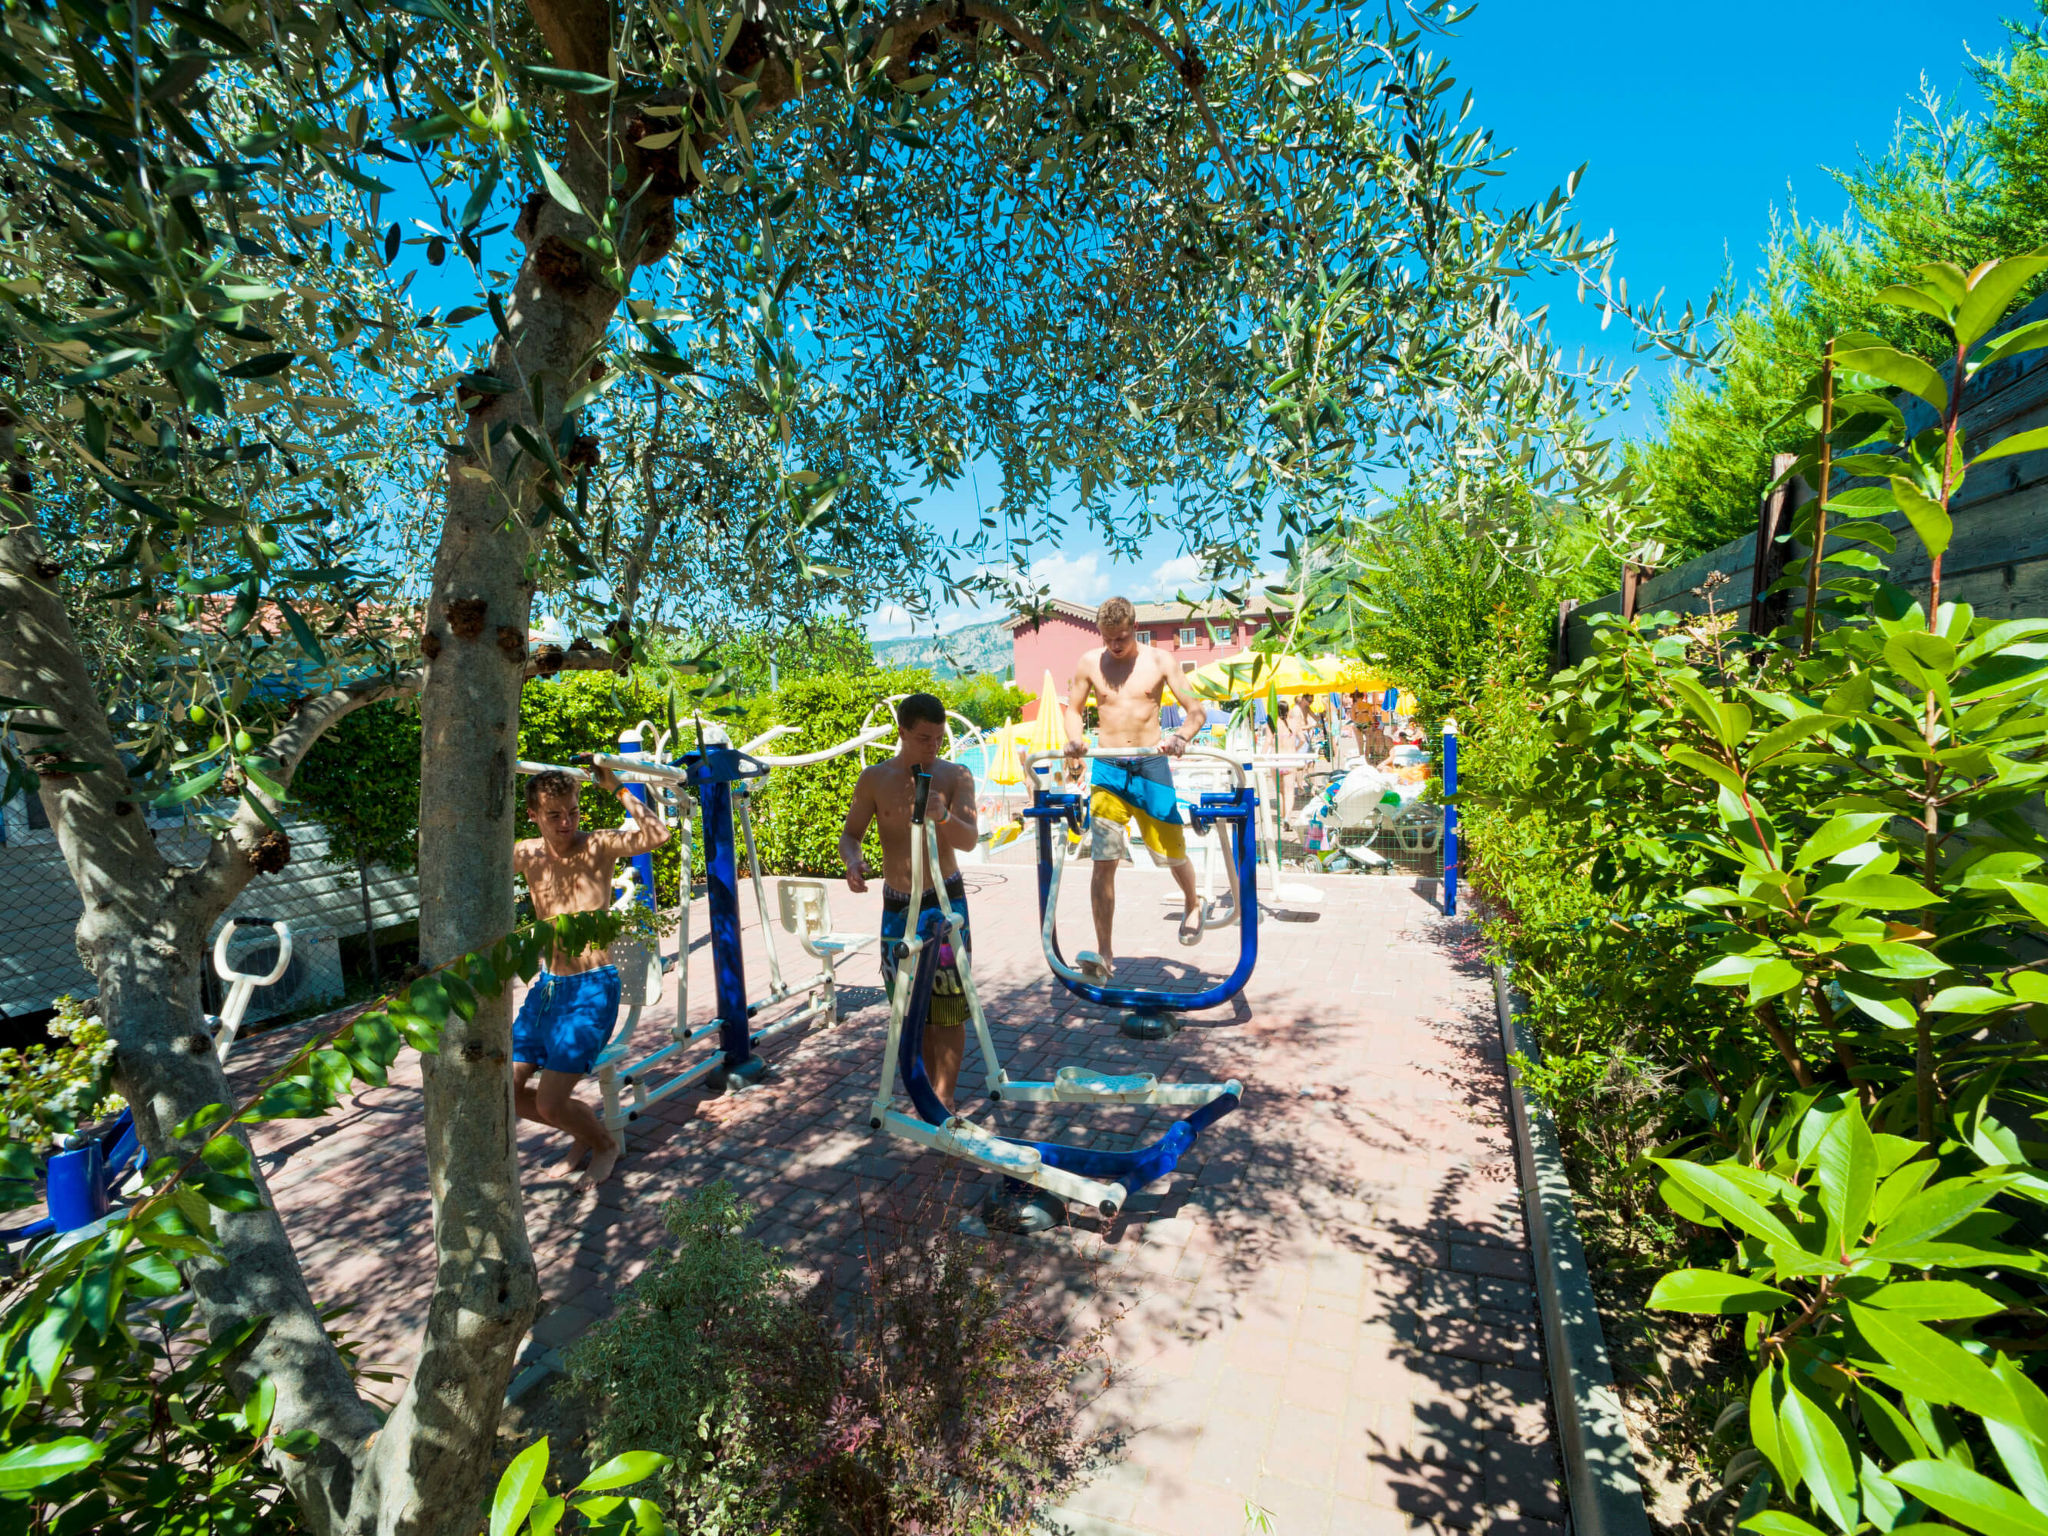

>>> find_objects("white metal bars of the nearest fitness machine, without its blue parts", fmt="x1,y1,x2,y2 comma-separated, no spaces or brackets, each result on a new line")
868,786,1243,1217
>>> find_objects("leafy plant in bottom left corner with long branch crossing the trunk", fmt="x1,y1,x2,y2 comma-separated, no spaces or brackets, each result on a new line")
0,911,623,1536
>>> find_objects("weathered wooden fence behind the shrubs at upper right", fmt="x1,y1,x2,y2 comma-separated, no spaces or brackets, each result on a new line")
1559,297,2048,662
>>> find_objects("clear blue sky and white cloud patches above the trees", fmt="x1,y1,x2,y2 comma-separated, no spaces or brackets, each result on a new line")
868,0,2034,639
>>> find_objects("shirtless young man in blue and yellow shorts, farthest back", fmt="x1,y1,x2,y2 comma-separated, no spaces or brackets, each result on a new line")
1067,598,1208,975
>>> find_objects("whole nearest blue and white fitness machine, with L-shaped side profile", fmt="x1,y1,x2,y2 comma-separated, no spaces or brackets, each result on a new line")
868,770,1243,1219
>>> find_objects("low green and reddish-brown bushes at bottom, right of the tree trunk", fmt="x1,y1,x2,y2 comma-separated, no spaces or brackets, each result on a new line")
567,1184,1100,1536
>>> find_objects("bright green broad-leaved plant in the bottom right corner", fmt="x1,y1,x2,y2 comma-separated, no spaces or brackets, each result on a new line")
1651,1094,2048,1536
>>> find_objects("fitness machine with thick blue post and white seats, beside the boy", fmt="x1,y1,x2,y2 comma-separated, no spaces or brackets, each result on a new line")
518,721,887,1133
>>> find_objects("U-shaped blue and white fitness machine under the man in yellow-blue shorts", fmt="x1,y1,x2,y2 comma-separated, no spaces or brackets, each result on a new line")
1024,748,1260,1040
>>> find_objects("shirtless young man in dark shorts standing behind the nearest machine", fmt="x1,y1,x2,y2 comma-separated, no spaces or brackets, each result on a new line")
840,694,981,1110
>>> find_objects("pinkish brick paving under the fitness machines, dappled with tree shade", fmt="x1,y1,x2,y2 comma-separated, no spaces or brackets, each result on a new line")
238,864,1565,1536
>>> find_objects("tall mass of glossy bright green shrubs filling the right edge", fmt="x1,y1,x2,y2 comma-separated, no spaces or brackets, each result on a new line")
1638,252,2048,1536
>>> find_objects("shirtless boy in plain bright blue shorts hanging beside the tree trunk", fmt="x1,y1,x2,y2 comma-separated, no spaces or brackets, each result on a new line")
512,768,668,1188
